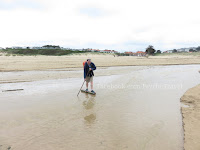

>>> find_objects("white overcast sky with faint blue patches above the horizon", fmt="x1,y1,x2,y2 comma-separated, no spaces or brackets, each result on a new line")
0,0,200,51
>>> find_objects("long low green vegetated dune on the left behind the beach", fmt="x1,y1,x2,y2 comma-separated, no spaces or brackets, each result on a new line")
1,49,87,56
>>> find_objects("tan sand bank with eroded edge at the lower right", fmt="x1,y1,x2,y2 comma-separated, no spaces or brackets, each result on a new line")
181,85,200,150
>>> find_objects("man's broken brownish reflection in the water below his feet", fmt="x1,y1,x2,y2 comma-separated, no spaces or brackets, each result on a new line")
83,94,96,125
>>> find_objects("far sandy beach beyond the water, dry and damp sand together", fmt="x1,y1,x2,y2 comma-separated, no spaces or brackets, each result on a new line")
0,54,200,83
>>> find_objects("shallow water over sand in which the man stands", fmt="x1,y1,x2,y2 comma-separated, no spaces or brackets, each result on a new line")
0,65,200,150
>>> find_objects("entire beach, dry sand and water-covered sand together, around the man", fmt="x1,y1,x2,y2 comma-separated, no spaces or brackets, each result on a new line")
0,55,200,150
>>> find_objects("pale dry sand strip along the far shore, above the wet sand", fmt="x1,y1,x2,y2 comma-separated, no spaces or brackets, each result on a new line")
0,54,200,71
